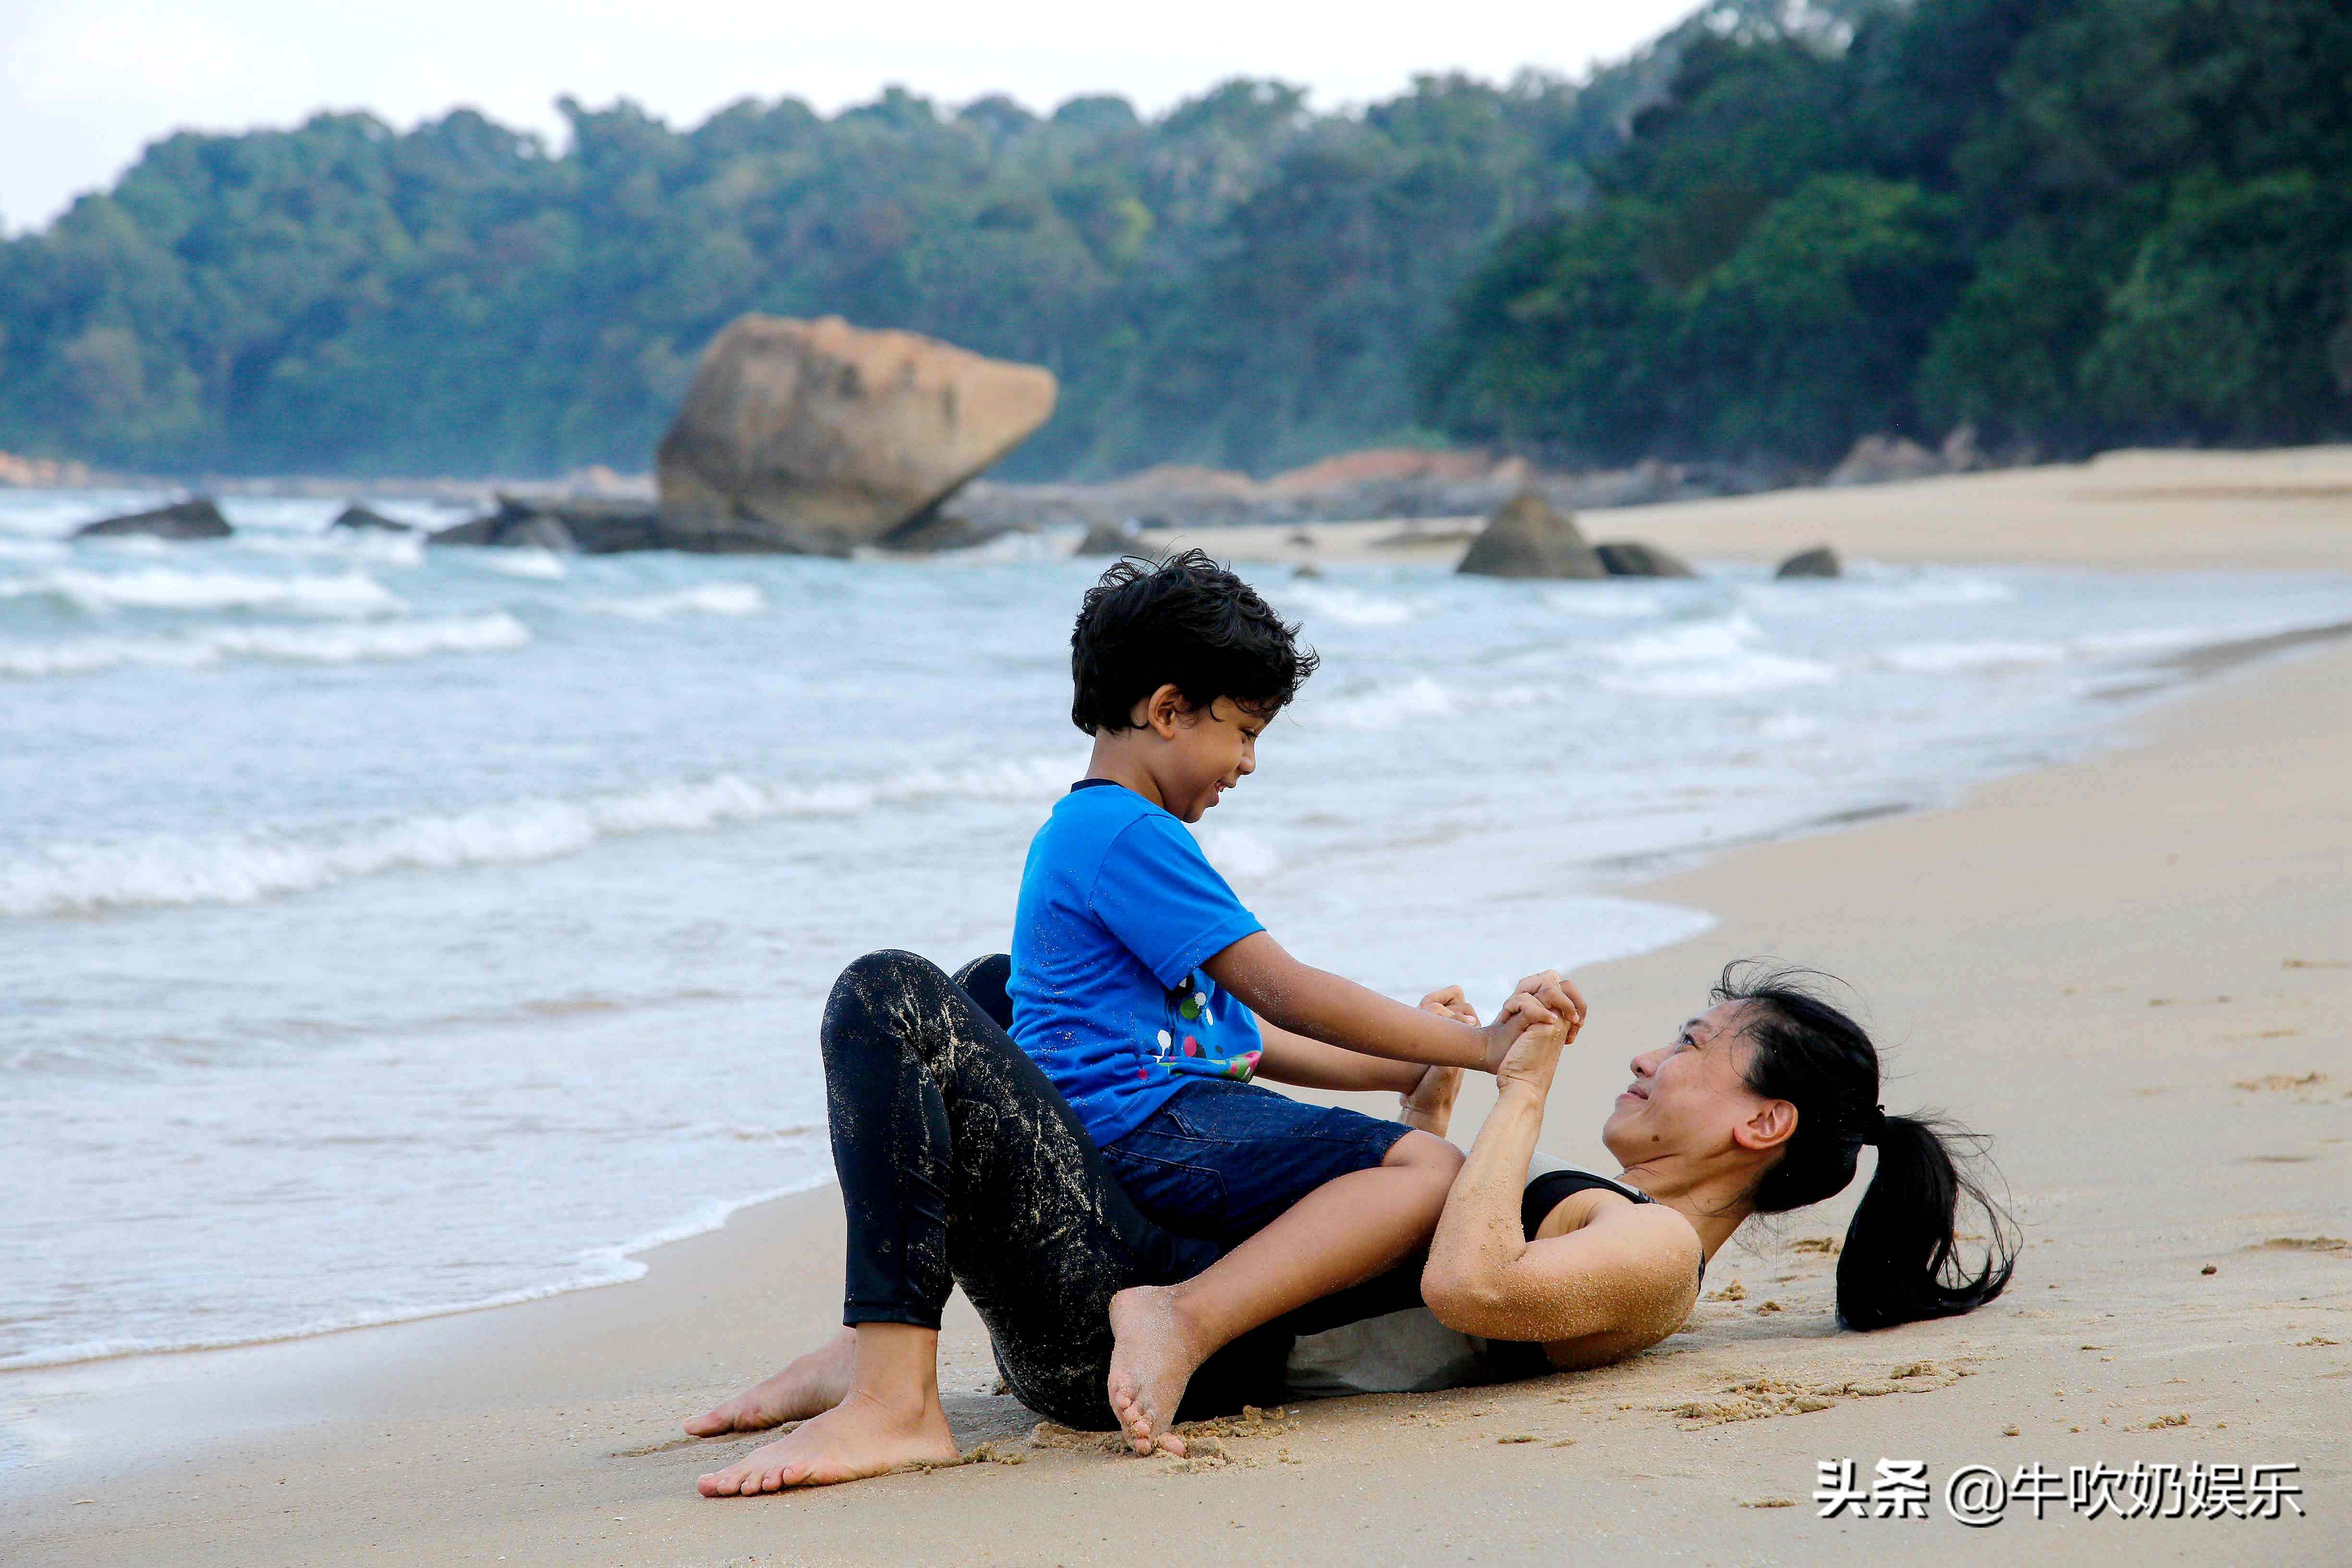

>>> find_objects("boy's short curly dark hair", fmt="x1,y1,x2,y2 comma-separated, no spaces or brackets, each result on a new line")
1070,550,1320,736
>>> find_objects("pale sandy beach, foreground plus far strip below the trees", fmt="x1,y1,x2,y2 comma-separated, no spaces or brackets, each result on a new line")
0,449,2352,1566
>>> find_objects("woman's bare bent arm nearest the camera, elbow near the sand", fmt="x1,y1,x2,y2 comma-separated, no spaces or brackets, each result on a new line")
1420,1027,1698,1354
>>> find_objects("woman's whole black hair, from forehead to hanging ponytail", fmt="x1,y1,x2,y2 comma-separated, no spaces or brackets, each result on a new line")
1715,964,2018,1328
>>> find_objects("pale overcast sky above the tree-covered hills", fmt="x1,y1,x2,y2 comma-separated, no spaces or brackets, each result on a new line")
0,0,1698,233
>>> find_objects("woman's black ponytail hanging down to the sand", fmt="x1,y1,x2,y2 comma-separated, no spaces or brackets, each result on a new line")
1834,1109,2018,1328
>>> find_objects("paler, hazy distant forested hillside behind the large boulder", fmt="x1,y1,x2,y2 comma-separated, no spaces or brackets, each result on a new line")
0,48,1663,475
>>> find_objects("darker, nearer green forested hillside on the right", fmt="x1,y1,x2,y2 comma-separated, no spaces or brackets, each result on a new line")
1420,0,2352,463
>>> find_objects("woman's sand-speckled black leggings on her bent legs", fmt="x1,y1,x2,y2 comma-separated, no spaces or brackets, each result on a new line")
823,952,1308,1429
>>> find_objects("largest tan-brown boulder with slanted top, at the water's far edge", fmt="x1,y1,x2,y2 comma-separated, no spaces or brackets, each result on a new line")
654,315,1058,555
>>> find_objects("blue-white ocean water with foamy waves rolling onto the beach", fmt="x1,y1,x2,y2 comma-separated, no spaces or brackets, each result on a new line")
0,491,2352,1368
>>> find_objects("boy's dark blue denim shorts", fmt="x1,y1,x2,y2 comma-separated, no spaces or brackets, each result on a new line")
1103,1079,1411,1246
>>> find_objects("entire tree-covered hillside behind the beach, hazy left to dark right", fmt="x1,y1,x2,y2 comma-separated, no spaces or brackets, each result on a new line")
0,0,2352,477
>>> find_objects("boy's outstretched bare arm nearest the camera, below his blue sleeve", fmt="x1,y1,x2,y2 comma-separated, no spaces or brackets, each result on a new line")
1202,931,1585,1072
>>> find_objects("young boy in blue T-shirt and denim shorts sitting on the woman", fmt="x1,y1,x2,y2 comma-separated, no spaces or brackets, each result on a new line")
1009,550,1580,1453
